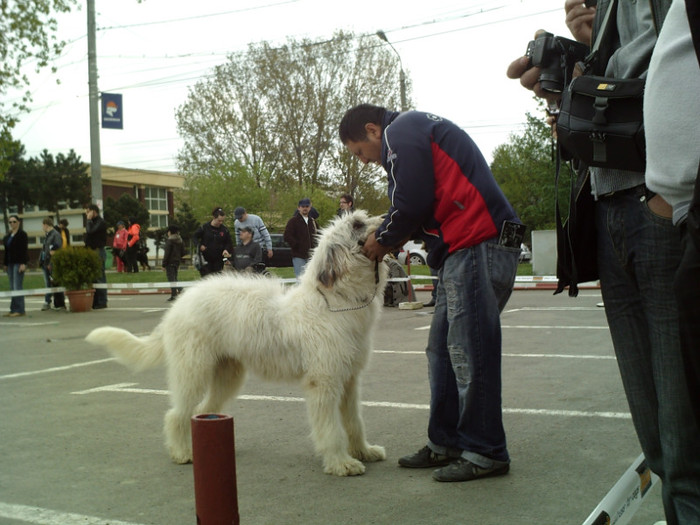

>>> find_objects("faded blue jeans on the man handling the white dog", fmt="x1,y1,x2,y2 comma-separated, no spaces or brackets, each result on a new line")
426,240,520,468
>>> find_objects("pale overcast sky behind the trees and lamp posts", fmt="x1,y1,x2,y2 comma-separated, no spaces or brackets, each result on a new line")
11,0,570,171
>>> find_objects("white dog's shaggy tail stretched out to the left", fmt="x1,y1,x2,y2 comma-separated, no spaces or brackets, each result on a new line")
85,326,165,372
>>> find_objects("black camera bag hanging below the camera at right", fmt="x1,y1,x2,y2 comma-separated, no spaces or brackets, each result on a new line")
557,75,646,171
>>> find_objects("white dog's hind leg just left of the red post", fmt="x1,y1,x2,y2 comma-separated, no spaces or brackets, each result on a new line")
164,348,216,463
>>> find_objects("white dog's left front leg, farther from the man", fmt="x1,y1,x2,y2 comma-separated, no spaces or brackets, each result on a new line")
304,378,365,476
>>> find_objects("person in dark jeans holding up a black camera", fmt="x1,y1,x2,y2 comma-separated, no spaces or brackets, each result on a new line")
507,0,700,524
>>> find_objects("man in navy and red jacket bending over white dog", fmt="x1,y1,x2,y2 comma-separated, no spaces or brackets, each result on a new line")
340,104,521,481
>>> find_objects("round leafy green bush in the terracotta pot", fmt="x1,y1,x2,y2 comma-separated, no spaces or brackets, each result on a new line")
51,246,102,290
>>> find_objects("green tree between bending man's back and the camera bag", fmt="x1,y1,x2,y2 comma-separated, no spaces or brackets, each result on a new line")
491,113,568,236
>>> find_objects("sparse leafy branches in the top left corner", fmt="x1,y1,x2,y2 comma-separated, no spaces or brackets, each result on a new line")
0,0,76,131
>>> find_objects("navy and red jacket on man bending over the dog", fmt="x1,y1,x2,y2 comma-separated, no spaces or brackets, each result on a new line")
377,111,520,268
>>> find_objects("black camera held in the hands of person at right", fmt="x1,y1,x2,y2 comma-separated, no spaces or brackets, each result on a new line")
525,32,588,93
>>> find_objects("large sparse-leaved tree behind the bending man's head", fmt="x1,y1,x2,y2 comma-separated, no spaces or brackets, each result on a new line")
176,32,402,216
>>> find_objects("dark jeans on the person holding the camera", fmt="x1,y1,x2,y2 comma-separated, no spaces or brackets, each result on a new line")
596,186,700,525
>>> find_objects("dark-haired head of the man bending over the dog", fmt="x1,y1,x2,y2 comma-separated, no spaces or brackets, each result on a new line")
338,104,386,164
